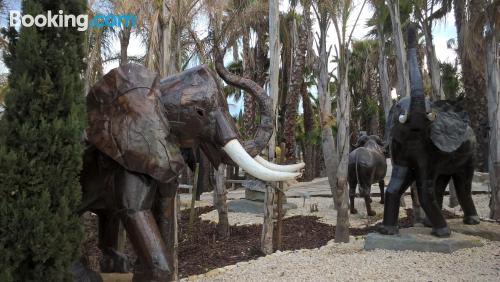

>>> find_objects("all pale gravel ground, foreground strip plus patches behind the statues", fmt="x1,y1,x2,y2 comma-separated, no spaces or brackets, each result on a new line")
178,195,500,281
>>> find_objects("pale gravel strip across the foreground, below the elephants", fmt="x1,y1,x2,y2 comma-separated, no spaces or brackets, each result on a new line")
184,237,500,281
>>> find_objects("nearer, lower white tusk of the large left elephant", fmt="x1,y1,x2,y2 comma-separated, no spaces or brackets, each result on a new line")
222,139,301,181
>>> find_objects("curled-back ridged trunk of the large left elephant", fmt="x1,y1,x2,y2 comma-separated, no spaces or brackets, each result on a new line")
215,50,274,157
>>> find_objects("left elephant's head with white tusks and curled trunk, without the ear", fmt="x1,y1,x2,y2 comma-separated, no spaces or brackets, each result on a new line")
156,53,304,181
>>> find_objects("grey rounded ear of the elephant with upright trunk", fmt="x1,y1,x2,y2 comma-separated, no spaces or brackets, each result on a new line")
431,101,473,153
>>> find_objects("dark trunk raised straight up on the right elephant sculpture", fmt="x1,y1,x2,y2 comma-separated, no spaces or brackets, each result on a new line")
408,23,426,120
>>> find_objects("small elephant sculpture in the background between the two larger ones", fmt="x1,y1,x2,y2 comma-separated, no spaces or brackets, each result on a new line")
347,135,387,216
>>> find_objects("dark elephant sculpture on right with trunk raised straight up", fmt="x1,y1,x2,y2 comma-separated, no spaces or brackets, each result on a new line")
379,24,479,237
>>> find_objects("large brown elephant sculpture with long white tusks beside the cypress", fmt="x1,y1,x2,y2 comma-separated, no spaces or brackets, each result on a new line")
80,51,304,281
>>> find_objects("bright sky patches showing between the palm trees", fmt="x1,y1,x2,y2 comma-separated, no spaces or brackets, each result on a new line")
0,0,456,115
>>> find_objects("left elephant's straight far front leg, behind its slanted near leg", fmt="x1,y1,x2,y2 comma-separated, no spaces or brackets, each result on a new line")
154,179,179,281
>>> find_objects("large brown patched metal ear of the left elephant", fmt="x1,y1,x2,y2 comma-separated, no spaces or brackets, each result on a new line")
86,64,184,183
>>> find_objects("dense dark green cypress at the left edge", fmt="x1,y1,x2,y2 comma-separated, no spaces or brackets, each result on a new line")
0,0,86,281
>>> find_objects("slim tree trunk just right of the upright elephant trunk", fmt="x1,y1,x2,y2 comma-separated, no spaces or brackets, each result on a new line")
422,20,444,101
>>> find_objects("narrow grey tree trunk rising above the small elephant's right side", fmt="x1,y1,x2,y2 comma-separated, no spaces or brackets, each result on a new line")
377,19,392,119
